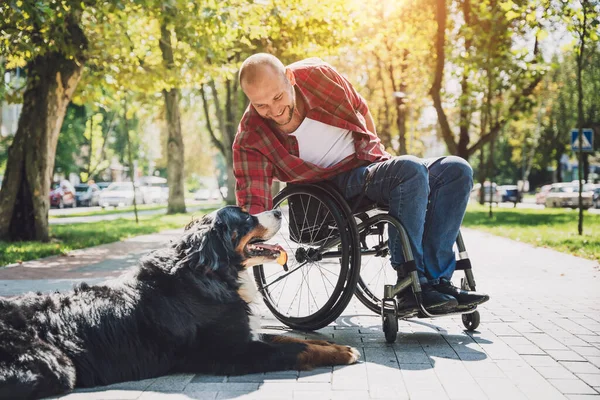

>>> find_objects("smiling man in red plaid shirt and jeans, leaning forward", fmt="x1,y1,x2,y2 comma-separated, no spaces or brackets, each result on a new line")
233,54,489,313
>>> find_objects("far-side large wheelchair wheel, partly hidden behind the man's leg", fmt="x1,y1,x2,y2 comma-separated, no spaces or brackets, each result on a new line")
355,214,398,314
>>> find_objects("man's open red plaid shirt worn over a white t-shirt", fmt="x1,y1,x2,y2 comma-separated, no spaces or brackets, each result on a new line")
233,58,390,214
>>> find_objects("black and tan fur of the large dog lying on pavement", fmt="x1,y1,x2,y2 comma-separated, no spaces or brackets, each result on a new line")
0,207,358,399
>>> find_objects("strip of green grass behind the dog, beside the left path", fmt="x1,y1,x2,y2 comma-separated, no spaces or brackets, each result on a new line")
0,208,212,267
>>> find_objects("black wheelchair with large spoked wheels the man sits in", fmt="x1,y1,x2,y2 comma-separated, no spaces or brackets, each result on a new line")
253,182,480,343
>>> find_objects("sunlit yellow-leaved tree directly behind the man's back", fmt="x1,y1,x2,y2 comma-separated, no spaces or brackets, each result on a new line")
334,0,435,154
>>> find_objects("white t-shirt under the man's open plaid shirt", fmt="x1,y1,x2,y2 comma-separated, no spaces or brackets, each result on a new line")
290,118,355,168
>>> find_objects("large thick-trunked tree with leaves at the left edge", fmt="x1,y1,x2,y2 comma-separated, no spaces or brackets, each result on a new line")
0,1,88,241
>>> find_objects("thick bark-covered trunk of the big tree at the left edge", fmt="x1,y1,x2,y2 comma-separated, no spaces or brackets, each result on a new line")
0,51,85,241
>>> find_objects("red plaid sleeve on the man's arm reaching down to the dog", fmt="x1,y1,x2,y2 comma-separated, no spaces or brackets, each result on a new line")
233,138,273,214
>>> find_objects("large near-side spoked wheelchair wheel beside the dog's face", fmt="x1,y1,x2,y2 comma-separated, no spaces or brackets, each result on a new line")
254,185,360,330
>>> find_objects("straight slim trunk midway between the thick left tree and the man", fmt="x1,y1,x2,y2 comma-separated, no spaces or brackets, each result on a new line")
159,21,186,214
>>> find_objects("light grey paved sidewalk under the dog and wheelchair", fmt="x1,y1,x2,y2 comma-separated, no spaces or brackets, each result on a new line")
0,229,600,400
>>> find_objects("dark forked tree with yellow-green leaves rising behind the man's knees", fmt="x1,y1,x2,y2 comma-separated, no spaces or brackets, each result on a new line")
430,0,543,159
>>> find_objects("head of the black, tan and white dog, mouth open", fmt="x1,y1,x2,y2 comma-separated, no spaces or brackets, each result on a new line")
176,206,281,271
